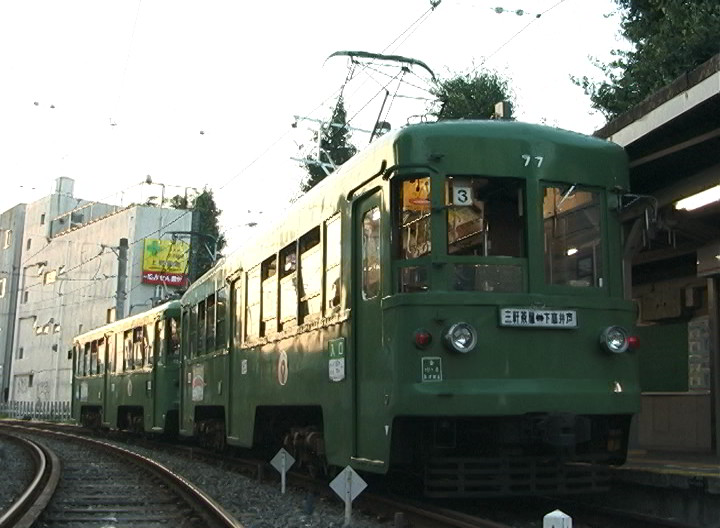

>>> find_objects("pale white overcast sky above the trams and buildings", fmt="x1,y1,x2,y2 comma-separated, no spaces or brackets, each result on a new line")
0,0,627,252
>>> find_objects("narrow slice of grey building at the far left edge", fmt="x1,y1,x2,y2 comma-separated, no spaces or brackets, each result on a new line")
0,204,25,402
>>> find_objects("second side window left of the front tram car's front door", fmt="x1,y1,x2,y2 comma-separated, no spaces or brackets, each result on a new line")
300,227,323,322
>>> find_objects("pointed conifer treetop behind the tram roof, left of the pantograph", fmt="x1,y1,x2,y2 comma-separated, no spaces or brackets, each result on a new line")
301,97,357,192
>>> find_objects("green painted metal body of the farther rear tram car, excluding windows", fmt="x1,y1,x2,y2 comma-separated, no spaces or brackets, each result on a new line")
72,301,180,432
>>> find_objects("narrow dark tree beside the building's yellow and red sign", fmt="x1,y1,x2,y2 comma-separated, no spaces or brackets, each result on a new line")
170,189,227,282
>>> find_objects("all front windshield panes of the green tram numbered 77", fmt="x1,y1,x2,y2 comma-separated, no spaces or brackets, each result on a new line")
393,175,606,293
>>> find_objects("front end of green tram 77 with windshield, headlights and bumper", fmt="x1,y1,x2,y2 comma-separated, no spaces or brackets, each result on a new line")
366,121,640,497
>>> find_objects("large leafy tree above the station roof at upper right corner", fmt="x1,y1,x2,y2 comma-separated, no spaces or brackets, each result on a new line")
573,0,720,119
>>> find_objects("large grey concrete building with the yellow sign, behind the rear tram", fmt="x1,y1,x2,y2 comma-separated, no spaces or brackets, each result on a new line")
10,178,192,402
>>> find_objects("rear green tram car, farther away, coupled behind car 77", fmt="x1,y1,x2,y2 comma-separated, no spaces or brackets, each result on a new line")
72,301,180,434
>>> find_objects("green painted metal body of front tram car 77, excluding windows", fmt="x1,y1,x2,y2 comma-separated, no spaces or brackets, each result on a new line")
181,122,639,482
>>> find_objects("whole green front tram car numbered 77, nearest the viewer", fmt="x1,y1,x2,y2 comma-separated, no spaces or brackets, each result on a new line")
180,121,640,497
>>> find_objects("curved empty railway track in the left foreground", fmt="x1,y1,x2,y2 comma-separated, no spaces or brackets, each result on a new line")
2,425,241,528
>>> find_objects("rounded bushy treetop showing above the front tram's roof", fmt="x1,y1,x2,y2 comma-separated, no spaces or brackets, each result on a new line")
430,70,512,120
